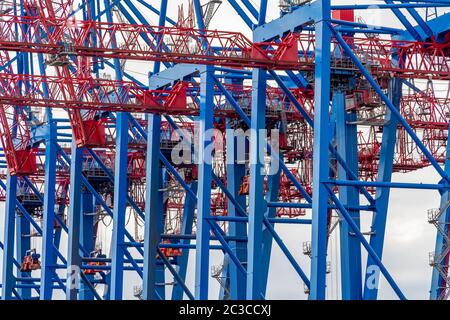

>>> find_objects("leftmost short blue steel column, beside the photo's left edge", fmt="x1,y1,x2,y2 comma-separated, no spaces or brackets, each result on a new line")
2,173,17,300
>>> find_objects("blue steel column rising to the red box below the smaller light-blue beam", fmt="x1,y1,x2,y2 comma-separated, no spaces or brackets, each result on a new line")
142,114,163,300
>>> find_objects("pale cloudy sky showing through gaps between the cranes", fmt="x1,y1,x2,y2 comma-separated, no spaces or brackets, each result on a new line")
0,0,446,299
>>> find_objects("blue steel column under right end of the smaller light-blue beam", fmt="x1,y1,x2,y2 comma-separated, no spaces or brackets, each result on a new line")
195,66,214,300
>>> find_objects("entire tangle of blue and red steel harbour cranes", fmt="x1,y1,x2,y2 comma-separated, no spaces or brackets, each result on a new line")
0,0,450,300
